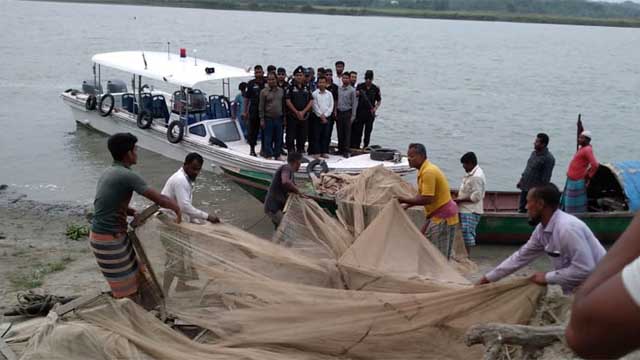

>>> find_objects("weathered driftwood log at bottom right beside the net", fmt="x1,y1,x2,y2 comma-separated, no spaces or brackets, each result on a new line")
464,324,565,360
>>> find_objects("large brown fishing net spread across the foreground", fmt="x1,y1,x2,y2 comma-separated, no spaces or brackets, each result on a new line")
7,167,543,360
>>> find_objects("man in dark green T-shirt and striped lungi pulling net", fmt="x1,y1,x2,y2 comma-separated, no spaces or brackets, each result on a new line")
89,133,182,307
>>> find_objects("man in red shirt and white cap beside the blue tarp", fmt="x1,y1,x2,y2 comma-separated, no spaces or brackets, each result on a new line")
562,130,600,213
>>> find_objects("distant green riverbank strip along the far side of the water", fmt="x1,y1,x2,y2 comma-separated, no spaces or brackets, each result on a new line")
41,0,640,27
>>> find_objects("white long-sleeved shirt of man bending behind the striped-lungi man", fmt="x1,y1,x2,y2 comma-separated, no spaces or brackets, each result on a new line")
162,167,209,222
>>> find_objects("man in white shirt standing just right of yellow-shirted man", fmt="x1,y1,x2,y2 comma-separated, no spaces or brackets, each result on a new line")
454,152,486,253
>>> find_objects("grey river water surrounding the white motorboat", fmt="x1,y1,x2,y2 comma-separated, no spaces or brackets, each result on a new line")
0,0,640,235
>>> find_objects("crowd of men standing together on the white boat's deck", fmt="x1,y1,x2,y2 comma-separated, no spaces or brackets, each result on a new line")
232,61,382,160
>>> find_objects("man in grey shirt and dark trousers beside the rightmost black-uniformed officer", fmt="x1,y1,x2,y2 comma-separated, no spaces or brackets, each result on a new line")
336,72,358,157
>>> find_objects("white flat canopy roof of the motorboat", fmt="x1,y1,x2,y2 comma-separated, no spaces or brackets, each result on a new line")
91,51,253,88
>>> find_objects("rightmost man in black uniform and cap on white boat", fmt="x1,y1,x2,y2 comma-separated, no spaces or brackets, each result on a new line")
351,70,382,149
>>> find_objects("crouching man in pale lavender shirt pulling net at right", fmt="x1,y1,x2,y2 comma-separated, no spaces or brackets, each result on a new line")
478,183,606,294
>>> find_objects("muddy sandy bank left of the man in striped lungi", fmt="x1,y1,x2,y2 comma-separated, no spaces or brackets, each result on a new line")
0,188,106,314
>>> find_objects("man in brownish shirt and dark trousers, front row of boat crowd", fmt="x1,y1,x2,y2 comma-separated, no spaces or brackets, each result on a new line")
260,72,284,160
